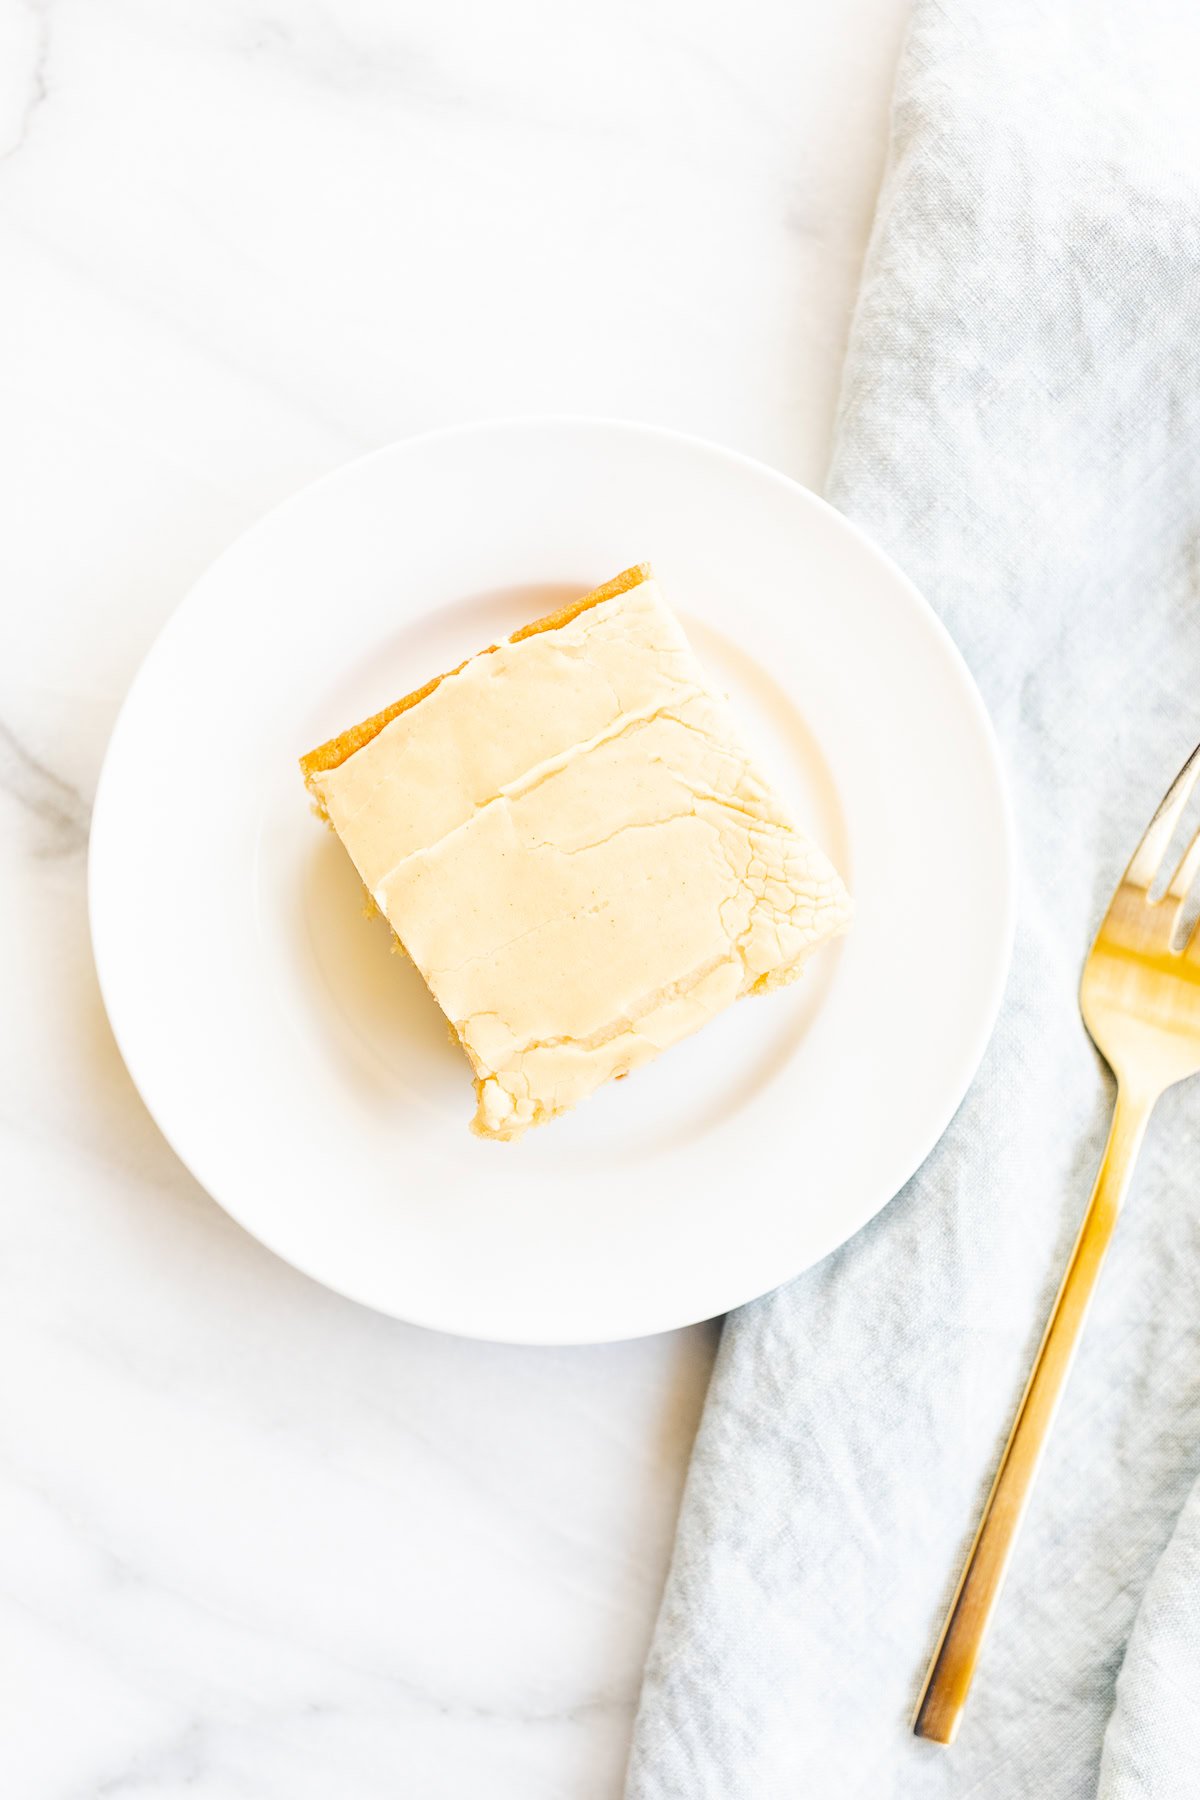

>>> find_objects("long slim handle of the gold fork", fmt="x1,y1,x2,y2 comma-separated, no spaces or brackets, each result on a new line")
912,1085,1157,1744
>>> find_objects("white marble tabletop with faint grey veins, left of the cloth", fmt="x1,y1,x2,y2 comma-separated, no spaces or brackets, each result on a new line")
0,0,905,1800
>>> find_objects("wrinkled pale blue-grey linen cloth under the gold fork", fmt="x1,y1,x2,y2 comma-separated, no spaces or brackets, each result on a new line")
628,0,1200,1800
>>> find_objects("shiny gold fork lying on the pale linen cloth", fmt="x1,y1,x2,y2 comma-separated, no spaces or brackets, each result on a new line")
912,745,1200,1744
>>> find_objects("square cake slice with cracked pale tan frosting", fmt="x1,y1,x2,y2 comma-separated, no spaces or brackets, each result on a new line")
300,565,851,1138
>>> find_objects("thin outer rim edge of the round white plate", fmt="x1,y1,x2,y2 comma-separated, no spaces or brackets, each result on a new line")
86,412,1018,1348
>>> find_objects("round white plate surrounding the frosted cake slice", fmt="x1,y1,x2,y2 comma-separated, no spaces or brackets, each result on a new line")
90,419,1013,1343
